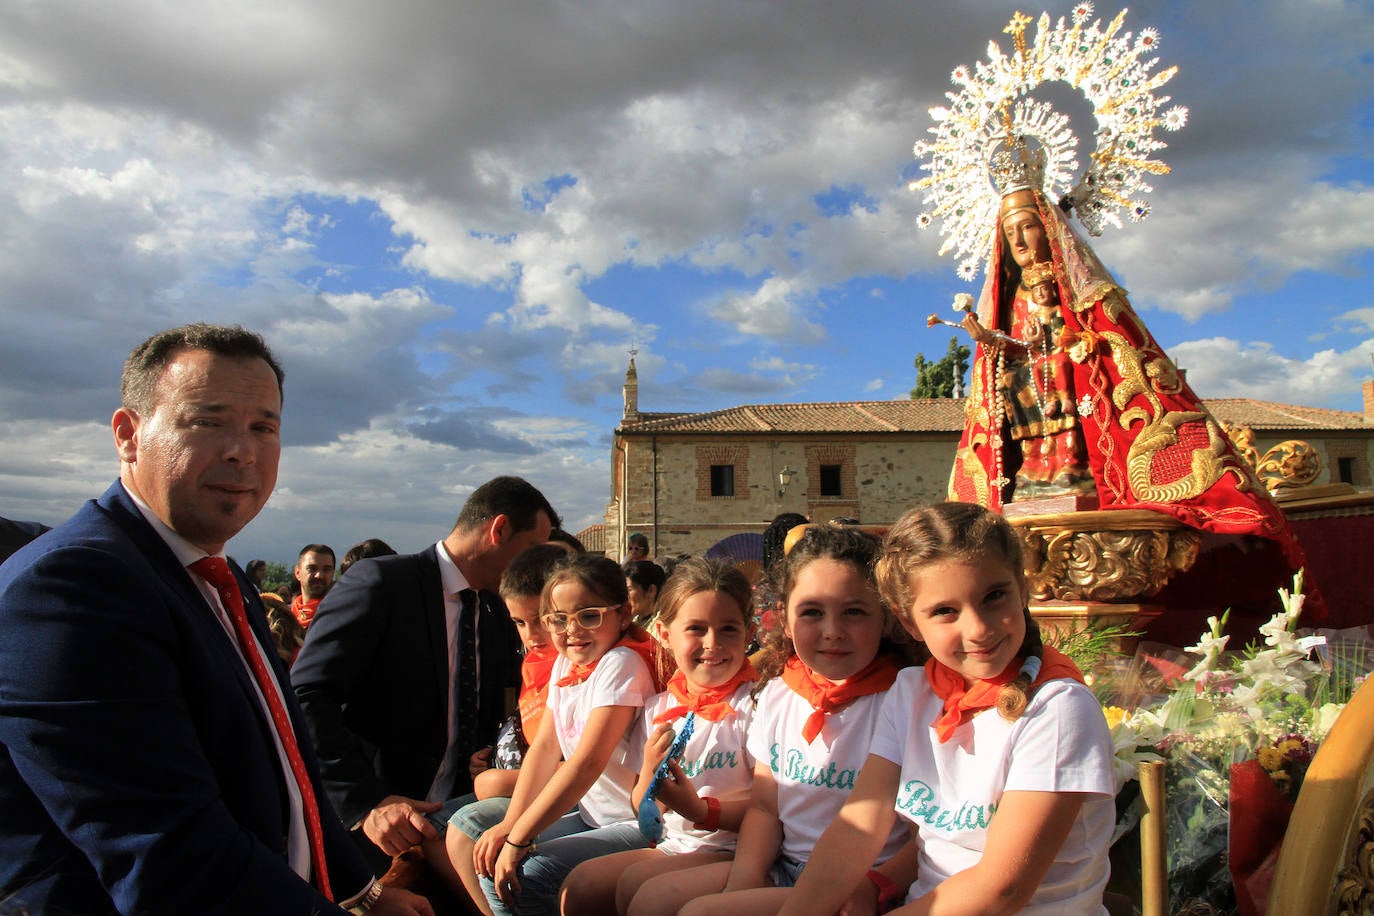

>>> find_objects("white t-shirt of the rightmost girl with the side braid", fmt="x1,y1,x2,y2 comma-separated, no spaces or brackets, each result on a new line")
872,667,1116,916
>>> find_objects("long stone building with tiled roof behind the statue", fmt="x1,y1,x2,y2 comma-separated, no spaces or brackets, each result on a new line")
601,358,1374,559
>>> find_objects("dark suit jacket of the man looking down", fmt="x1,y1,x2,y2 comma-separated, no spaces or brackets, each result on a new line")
291,547,519,824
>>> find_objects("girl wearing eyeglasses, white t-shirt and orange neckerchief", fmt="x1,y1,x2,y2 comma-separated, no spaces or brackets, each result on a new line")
473,553,658,915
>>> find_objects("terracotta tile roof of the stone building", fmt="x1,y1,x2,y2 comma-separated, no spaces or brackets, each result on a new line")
618,398,1374,435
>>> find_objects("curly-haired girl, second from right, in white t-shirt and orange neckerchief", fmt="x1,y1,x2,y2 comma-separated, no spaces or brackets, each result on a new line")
662,526,914,916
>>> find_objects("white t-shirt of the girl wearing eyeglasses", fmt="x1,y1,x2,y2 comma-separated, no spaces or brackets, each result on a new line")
548,645,654,827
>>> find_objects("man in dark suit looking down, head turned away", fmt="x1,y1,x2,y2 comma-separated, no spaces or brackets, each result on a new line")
291,477,558,861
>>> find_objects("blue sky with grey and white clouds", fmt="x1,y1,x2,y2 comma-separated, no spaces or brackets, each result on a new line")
0,0,1374,560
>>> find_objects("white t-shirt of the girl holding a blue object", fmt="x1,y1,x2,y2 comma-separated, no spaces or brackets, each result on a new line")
640,681,754,853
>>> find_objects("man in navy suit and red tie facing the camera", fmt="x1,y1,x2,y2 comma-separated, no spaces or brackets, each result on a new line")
0,324,431,916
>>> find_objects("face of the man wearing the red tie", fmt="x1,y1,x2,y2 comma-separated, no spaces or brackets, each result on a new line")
110,350,282,553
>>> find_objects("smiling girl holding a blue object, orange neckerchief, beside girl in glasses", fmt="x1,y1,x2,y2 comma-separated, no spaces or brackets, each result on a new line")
563,559,757,916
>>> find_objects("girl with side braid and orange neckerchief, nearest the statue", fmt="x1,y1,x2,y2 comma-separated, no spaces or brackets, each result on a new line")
783,503,1116,916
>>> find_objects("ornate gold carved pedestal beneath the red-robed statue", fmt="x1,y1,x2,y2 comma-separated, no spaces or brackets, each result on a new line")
1013,511,1202,602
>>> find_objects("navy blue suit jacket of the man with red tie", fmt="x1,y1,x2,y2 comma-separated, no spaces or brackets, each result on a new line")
0,482,371,916
